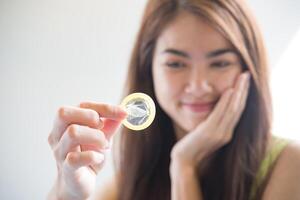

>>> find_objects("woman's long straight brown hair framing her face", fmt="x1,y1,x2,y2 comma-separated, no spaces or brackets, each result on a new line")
115,0,272,200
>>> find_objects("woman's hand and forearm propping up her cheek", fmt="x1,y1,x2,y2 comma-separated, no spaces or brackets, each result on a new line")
170,72,250,200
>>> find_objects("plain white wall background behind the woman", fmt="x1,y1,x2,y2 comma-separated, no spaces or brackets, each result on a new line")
0,0,300,200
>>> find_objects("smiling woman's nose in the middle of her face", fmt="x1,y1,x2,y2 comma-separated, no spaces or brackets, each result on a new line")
185,72,213,96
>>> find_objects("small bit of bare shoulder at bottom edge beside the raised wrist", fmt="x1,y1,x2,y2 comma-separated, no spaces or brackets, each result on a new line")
92,176,118,200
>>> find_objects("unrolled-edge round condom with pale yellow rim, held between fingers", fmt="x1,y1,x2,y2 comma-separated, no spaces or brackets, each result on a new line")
121,93,156,131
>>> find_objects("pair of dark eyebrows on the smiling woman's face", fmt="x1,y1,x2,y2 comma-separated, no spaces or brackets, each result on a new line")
162,48,237,58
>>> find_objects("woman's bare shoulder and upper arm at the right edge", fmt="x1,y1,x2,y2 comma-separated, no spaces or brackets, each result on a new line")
263,138,300,200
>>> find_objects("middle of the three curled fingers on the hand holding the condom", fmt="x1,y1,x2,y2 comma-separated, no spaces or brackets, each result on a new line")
54,124,109,163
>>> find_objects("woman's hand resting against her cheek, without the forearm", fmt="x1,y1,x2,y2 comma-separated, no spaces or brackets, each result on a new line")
171,72,250,167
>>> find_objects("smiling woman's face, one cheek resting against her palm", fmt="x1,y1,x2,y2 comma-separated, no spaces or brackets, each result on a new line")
152,12,242,138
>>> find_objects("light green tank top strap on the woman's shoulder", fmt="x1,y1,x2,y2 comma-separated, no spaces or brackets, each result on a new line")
250,136,289,200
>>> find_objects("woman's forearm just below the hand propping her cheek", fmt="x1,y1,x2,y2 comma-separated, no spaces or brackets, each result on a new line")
170,159,203,200
